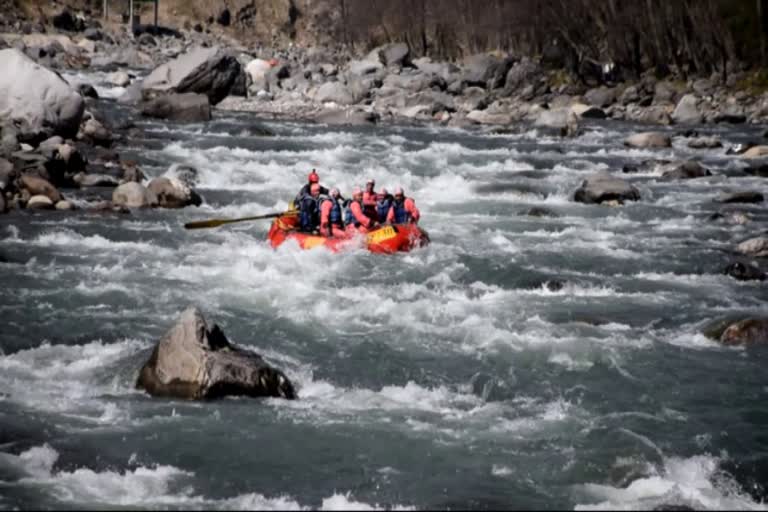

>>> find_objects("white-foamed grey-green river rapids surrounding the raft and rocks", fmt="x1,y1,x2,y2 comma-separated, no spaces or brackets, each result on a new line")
0,74,768,509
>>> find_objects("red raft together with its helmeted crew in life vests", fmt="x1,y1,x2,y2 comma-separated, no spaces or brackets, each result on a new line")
268,169,429,253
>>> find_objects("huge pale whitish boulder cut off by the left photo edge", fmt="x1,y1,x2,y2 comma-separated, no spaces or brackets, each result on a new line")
0,49,85,142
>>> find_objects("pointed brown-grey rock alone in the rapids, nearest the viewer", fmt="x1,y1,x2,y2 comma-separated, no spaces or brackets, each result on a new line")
136,307,296,400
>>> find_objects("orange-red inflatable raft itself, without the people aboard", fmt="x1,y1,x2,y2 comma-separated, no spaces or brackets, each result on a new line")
267,215,429,254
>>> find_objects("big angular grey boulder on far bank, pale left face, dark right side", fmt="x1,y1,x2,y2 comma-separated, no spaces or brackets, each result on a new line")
142,47,241,105
